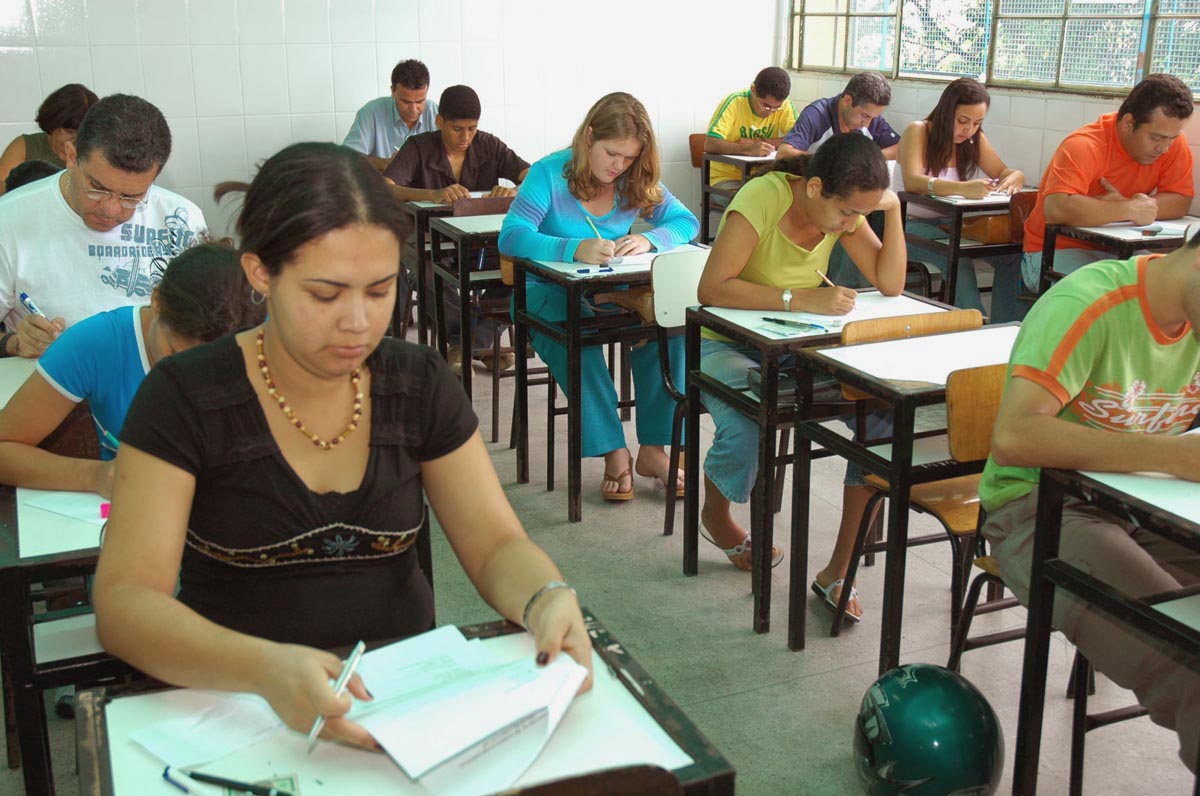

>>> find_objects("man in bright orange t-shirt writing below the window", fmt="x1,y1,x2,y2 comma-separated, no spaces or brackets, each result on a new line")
1021,74,1195,291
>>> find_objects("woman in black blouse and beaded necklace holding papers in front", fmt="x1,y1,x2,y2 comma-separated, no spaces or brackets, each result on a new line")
95,144,590,746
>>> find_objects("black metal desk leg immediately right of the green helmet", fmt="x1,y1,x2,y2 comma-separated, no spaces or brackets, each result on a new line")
1013,477,1063,796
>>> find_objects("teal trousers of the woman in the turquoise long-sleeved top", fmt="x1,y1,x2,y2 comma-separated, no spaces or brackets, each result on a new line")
526,279,684,456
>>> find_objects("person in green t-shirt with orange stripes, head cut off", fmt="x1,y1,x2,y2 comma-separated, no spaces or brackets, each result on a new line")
979,225,1200,772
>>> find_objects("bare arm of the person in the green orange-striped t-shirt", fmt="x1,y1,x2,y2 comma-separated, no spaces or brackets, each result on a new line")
991,377,1200,481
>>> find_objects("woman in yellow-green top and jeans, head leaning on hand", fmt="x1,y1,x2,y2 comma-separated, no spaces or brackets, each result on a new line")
700,132,906,622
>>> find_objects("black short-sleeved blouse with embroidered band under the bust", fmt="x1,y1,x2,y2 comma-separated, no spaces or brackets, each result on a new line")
121,336,479,648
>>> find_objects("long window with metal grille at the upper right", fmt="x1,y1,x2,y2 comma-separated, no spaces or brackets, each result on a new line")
790,0,1200,94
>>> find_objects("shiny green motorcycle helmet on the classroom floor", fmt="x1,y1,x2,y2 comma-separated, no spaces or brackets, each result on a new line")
854,664,1004,796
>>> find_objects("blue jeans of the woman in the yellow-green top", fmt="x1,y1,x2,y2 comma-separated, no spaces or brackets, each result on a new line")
700,339,892,503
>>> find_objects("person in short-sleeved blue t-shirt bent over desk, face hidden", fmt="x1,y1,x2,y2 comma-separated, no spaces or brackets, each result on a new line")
0,243,263,497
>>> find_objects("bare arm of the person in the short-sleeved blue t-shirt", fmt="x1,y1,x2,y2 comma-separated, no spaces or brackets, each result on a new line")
0,372,113,497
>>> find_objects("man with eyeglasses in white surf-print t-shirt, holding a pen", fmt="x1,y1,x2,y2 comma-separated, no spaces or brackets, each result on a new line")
0,94,204,358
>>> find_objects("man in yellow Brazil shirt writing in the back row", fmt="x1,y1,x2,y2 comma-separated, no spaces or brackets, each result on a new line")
704,66,796,200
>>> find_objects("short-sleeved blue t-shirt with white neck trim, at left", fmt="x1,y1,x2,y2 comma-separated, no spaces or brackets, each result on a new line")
37,305,150,461
